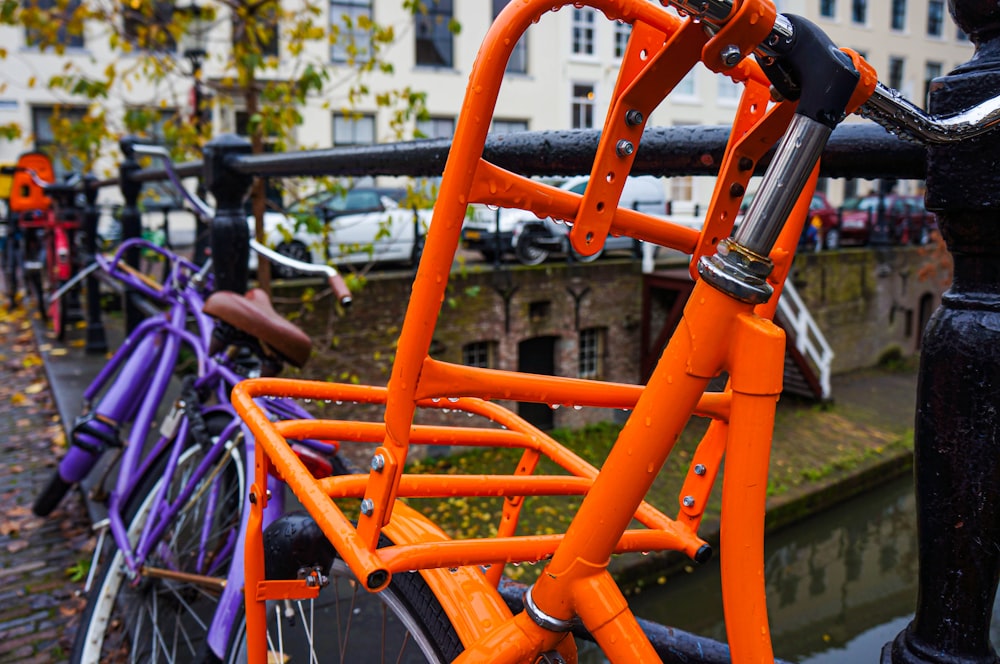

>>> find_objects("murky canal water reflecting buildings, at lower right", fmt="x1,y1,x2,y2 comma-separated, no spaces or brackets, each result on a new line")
581,476,1000,664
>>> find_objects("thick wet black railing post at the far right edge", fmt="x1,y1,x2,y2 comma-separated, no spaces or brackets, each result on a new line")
882,0,1000,664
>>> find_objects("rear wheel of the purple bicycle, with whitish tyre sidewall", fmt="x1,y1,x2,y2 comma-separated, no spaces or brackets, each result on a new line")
73,415,246,663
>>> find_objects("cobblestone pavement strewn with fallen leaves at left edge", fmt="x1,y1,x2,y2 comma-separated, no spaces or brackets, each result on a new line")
0,308,93,662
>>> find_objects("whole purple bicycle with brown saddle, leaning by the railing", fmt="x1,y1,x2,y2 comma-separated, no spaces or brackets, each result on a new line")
34,211,349,662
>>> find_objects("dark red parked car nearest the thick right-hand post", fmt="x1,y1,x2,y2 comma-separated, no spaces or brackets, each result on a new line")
840,194,937,245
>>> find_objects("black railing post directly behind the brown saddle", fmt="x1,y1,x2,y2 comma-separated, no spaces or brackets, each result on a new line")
204,134,253,293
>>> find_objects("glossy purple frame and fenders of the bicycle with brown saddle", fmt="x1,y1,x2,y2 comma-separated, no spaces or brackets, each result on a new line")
66,240,330,657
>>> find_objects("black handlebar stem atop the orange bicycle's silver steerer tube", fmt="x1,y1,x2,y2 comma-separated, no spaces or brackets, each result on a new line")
758,14,861,129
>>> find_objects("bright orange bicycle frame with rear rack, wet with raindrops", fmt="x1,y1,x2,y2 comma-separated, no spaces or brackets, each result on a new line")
233,0,876,663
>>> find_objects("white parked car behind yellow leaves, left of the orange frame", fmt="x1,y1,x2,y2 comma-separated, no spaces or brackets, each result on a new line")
251,187,431,277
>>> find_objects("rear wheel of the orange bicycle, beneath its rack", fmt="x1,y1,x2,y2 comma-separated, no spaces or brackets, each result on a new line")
225,536,462,664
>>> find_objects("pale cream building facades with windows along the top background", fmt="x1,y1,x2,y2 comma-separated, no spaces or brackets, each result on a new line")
0,0,973,204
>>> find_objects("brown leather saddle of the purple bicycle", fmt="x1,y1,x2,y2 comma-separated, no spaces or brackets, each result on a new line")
203,288,312,368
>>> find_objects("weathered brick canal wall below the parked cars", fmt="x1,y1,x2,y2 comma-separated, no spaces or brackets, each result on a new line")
276,248,943,434
